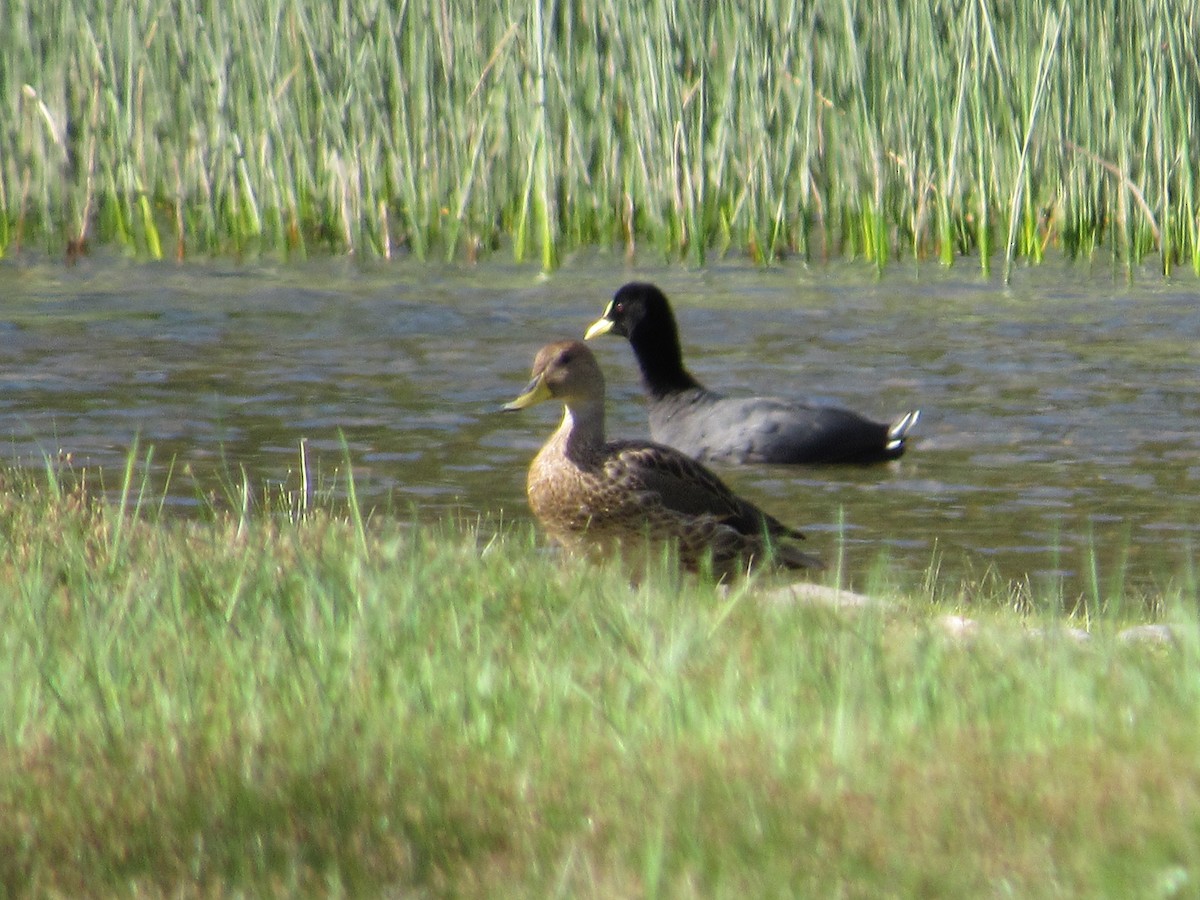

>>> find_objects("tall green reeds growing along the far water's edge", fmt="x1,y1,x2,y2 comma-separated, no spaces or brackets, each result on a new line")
0,0,1200,270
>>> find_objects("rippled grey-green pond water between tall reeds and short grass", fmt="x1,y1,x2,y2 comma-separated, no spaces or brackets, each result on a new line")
0,256,1200,602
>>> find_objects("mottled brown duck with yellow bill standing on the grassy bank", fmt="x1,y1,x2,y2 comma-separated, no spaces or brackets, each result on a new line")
503,340,822,580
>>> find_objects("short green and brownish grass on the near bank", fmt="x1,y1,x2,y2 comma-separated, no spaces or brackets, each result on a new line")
0,473,1200,896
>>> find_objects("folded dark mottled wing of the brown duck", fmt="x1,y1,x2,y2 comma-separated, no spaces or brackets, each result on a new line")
605,442,803,538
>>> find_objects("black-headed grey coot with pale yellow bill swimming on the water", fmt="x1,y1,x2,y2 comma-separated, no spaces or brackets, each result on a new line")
584,282,920,466
